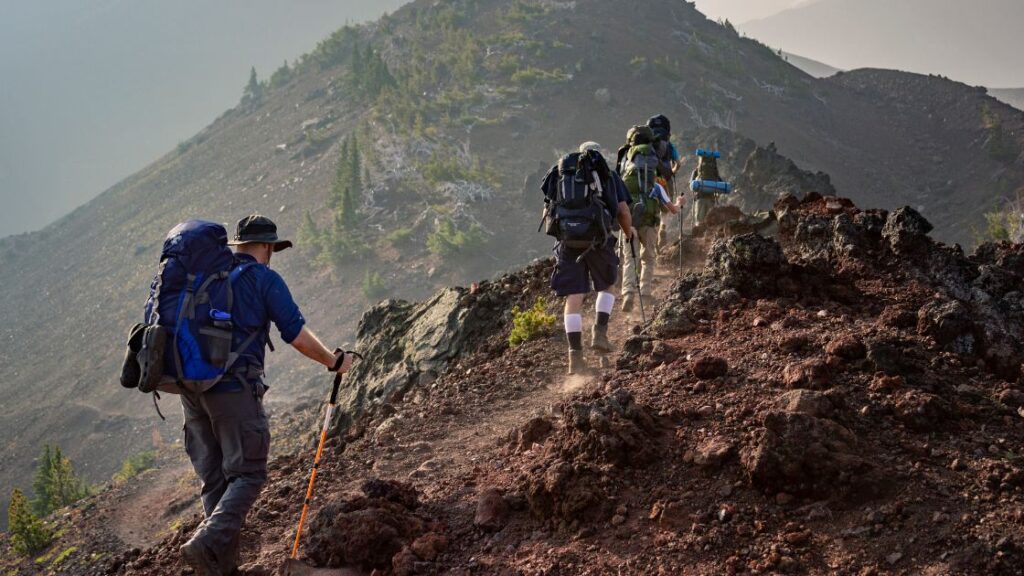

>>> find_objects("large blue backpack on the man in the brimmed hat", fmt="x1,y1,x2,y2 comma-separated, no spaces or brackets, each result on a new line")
137,220,264,394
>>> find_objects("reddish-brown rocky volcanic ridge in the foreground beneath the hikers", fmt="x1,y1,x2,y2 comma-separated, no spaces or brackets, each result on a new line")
8,192,1024,576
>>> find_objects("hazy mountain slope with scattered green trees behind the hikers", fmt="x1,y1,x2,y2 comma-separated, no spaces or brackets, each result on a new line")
0,0,1024,528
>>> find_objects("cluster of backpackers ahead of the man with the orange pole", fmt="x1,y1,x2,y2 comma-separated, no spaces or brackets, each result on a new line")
541,115,727,374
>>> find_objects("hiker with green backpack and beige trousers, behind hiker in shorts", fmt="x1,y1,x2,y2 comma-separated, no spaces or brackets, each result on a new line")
618,125,683,312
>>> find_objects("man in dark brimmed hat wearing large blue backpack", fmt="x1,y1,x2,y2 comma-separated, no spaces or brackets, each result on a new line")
121,215,352,576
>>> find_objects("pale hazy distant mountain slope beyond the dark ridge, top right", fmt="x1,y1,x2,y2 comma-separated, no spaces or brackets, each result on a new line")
740,0,1024,86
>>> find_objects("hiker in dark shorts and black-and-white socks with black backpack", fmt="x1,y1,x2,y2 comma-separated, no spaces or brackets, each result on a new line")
541,142,633,375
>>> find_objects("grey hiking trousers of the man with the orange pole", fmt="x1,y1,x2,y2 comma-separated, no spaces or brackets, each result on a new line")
181,381,270,567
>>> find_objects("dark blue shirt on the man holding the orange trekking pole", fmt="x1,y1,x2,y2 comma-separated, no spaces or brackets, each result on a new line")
210,254,306,392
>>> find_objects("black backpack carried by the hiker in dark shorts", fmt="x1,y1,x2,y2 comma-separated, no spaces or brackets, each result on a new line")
545,152,611,251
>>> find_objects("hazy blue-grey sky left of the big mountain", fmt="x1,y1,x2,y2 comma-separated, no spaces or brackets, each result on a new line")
0,0,404,237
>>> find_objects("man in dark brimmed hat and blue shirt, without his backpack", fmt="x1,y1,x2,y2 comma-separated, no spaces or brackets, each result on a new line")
181,215,352,576
